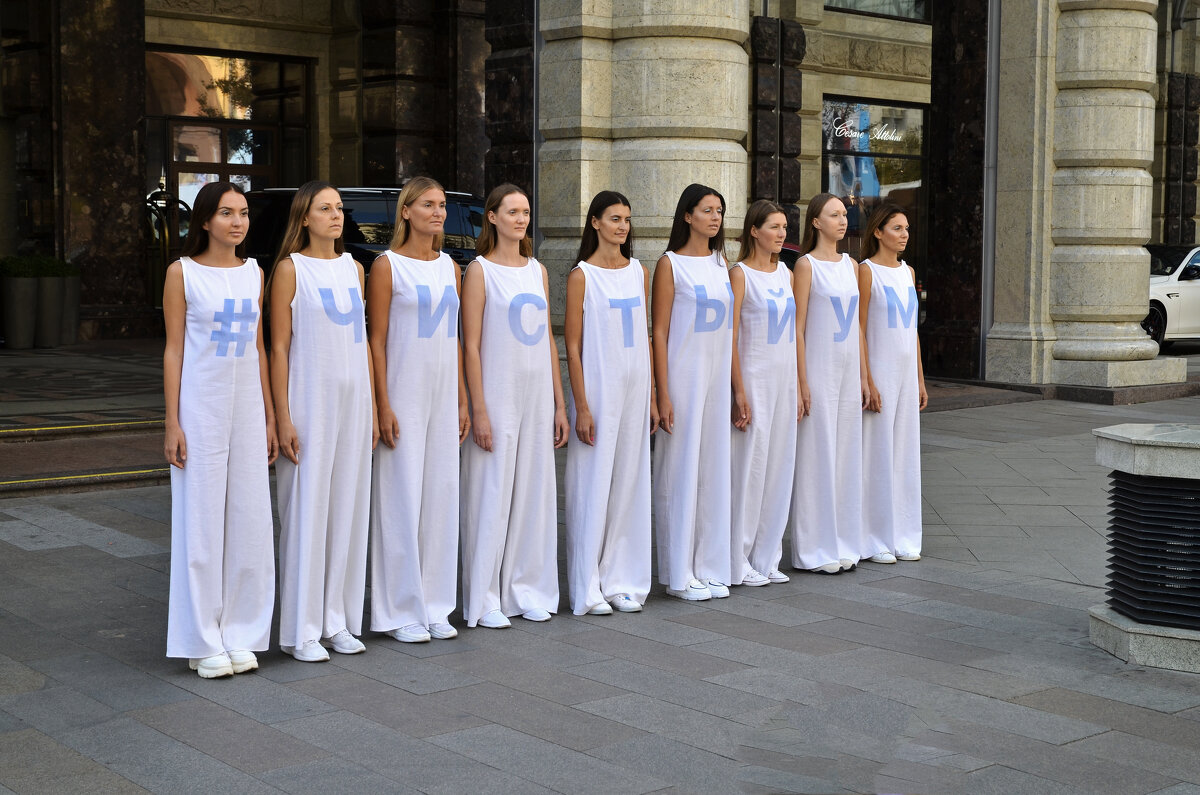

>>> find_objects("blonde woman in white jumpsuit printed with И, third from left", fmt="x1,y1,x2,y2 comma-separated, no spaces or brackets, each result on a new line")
367,177,469,642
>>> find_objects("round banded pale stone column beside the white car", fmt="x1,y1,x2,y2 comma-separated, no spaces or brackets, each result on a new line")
1050,0,1187,388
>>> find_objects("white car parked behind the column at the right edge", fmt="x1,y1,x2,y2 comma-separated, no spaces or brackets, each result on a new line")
1141,245,1200,348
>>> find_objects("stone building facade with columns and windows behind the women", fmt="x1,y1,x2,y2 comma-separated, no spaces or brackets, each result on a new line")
0,0,1200,387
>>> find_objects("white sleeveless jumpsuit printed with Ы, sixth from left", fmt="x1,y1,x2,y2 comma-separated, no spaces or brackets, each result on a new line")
654,251,733,591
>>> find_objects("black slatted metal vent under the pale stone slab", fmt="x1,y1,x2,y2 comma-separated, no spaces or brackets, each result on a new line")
1109,472,1200,629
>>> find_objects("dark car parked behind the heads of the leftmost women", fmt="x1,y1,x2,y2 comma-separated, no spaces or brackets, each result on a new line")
246,187,484,269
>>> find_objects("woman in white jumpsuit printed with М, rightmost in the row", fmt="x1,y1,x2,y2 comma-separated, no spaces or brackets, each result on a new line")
858,204,929,563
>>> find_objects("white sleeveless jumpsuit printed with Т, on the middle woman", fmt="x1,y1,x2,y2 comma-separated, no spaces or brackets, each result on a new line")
564,259,650,615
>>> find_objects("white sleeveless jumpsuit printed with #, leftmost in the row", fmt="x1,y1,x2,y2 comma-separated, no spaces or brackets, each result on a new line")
167,257,275,658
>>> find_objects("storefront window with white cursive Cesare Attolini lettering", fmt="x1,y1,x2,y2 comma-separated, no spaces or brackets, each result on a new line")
821,97,928,264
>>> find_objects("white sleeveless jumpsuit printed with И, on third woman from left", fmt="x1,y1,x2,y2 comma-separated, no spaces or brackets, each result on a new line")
371,251,458,632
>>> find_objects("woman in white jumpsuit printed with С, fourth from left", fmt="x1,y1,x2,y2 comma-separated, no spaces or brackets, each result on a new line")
461,185,569,629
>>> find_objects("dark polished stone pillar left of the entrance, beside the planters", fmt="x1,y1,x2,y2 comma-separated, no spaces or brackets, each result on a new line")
56,0,153,339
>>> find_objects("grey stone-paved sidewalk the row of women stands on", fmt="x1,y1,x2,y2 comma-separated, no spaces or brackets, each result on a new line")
0,398,1200,795
